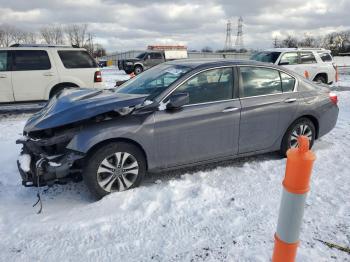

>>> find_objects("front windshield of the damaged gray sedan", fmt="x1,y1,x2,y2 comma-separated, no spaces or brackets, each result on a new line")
116,64,191,100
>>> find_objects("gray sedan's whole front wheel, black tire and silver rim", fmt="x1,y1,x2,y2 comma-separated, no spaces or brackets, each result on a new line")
83,142,146,199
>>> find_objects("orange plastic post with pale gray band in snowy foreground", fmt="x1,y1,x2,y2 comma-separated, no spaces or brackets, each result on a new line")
272,136,316,262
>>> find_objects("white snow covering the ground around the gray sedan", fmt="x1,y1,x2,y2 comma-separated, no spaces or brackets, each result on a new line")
0,69,350,261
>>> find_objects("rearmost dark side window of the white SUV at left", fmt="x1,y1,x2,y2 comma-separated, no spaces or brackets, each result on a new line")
58,50,97,68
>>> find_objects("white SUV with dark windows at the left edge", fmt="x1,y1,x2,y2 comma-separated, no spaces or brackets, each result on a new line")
0,44,103,103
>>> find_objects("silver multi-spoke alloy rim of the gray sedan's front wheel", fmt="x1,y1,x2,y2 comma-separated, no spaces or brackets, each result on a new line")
96,152,139,192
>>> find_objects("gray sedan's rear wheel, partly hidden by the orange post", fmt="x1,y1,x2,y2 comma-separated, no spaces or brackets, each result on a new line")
280,118,316,157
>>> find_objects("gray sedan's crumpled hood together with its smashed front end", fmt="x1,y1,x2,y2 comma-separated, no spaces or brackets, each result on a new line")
16,88,146,186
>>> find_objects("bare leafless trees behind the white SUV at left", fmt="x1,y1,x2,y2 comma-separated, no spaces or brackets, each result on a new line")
0,24,106,57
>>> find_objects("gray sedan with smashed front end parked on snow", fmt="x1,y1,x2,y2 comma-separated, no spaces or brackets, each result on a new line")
17,60,338,198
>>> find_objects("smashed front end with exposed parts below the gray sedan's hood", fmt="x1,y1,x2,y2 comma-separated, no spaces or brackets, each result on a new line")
16,128,84,187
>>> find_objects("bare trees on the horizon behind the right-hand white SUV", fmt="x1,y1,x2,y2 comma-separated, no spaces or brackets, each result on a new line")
272,30,350,55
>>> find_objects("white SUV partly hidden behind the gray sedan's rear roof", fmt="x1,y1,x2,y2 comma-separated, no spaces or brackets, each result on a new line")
251,48,336,84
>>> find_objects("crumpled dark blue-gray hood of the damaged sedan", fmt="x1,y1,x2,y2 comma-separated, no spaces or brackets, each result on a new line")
24,88,147,132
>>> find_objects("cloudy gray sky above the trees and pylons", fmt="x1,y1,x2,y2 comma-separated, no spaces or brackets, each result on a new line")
0,0,350,51
